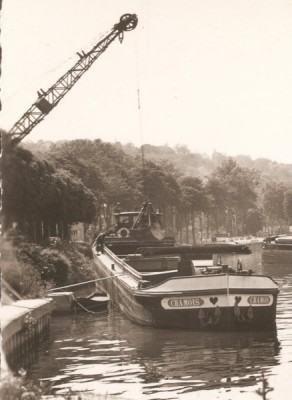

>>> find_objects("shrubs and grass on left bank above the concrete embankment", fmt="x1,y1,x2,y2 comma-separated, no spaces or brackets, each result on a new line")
1,232,95,299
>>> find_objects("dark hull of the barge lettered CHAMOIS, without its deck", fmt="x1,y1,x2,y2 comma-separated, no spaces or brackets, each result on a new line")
93,247,278,331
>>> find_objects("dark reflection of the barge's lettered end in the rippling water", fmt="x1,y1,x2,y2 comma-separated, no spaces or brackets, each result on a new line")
115,318,279,394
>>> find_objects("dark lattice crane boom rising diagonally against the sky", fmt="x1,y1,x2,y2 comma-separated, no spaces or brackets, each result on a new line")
8,14,138,143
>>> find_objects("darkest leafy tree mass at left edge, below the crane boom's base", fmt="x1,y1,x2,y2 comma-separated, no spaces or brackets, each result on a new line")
1,134,95,242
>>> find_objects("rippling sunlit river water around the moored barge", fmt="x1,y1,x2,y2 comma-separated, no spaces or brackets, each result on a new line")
28,246,292,400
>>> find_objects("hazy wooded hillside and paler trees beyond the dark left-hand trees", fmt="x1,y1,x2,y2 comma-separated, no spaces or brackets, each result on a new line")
16,139,292,243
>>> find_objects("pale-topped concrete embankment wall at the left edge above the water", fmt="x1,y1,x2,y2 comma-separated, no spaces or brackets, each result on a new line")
0,299,53,373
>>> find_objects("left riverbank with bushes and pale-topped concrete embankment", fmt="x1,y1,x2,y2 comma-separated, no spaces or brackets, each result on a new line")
0,232,110,400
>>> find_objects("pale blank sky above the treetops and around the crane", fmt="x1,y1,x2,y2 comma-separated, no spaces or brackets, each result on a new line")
0,0,292,163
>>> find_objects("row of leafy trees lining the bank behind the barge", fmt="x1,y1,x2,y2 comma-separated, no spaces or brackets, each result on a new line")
1,134,292,243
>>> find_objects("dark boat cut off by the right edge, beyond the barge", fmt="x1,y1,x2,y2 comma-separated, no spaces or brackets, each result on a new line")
262,235,292,267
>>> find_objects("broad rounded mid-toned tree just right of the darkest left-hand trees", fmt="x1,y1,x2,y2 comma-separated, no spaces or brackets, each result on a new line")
47,140,142,227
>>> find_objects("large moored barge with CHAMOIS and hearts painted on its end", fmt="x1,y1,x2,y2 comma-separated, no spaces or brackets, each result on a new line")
93,204,279,331
